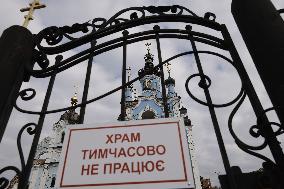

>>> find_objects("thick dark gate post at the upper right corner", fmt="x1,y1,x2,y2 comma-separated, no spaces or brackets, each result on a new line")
232,0,284,124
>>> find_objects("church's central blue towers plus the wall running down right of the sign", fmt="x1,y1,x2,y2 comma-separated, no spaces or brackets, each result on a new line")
121,49,201,189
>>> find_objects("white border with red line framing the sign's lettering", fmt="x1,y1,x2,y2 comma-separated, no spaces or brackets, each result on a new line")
56,118,194,189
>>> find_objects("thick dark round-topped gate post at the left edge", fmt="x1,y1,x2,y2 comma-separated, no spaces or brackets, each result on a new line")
0,26,34,142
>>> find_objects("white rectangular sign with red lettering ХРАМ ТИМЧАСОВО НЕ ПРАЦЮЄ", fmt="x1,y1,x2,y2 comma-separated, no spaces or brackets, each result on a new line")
56,118,194,189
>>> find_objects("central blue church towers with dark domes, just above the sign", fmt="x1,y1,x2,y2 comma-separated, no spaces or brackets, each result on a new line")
125,48,185,121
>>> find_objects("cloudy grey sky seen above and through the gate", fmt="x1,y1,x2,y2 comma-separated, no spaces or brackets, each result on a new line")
0,0,284,185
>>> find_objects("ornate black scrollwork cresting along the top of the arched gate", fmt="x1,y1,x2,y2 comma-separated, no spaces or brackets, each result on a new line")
35,5,203,52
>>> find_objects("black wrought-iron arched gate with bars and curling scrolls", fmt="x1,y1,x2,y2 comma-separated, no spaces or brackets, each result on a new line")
0,5,284,189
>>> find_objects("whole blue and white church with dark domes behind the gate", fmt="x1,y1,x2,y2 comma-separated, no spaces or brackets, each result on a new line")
10,49,201,189
